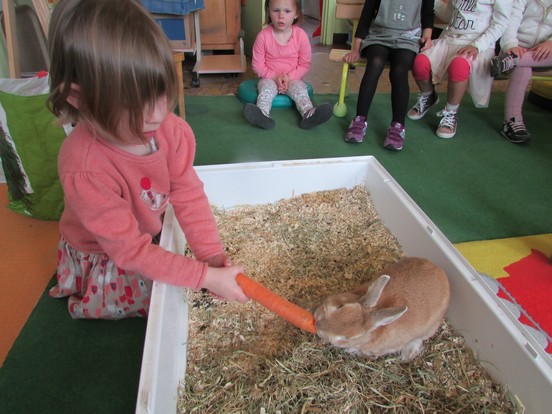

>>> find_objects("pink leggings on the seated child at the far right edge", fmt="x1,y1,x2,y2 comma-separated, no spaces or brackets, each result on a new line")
504,51,552,120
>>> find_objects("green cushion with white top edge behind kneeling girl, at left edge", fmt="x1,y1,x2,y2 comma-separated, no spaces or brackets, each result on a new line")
0,77,65,220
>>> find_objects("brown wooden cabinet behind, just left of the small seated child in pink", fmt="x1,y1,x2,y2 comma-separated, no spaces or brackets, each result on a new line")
199,0,240,53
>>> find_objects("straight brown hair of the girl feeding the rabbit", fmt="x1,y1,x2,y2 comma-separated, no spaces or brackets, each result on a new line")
48,0,177,140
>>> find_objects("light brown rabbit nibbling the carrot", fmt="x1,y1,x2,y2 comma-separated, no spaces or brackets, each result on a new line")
314,257,450,362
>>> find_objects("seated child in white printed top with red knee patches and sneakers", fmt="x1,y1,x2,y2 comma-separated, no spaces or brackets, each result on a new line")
407,0,512,138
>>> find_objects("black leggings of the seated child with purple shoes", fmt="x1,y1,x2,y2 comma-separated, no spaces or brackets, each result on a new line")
357,45,416,125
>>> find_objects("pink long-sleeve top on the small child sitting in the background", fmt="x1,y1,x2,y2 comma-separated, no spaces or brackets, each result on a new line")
252,25,312,80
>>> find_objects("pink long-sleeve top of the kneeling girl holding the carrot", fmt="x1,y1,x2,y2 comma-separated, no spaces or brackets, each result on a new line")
58,114,224,289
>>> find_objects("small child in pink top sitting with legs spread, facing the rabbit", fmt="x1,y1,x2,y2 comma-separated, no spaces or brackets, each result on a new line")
243,0,332,129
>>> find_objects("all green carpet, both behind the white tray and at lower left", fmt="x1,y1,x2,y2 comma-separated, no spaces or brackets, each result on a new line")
0,94,552,414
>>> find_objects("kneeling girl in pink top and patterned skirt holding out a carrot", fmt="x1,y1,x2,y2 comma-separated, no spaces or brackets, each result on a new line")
48,0,248,319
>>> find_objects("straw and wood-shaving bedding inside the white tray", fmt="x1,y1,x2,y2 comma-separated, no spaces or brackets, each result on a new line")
178,186,516,414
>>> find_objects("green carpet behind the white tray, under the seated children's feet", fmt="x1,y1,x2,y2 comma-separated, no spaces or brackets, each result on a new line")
186,94,552,242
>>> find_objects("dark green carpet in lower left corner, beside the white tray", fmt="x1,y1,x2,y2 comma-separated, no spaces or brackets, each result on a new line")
0,280,146,414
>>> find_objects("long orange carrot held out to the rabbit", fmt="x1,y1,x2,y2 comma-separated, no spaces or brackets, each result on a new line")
236,273,316,334
